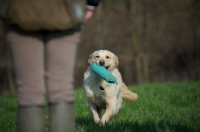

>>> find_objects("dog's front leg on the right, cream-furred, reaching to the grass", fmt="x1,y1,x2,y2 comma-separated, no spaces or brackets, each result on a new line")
101,98,117,125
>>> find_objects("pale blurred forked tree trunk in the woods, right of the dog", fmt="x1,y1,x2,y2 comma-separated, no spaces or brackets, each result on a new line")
125,0,149,84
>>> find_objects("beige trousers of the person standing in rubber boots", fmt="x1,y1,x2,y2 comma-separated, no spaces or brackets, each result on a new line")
7,26,80,106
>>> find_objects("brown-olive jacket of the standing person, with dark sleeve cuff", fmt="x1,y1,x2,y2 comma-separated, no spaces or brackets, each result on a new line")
0,0,100,31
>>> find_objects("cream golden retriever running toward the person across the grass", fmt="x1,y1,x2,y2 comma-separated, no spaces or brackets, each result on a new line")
84,50,138,125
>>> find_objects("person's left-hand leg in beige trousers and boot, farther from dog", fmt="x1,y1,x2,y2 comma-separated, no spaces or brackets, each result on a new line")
7,26,45,132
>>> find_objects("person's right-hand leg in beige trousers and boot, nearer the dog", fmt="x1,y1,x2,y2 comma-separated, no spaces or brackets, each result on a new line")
46,32,80,132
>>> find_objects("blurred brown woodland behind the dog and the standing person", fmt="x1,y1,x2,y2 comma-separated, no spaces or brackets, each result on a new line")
0,0,200,94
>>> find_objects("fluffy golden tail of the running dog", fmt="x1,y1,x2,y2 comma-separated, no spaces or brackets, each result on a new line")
122,84,138,102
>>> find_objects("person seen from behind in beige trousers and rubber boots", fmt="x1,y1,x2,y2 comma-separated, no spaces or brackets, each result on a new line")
0,0,100,132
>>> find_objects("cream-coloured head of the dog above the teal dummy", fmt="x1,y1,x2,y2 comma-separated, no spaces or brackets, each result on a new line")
88,50,119,71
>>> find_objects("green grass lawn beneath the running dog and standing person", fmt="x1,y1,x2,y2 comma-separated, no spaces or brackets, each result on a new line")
0,81,200,132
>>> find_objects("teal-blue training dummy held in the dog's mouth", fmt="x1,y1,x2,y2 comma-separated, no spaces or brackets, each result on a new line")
91,63,117,84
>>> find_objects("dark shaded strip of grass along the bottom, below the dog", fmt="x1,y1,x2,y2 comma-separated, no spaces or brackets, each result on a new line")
76,117,200,132
